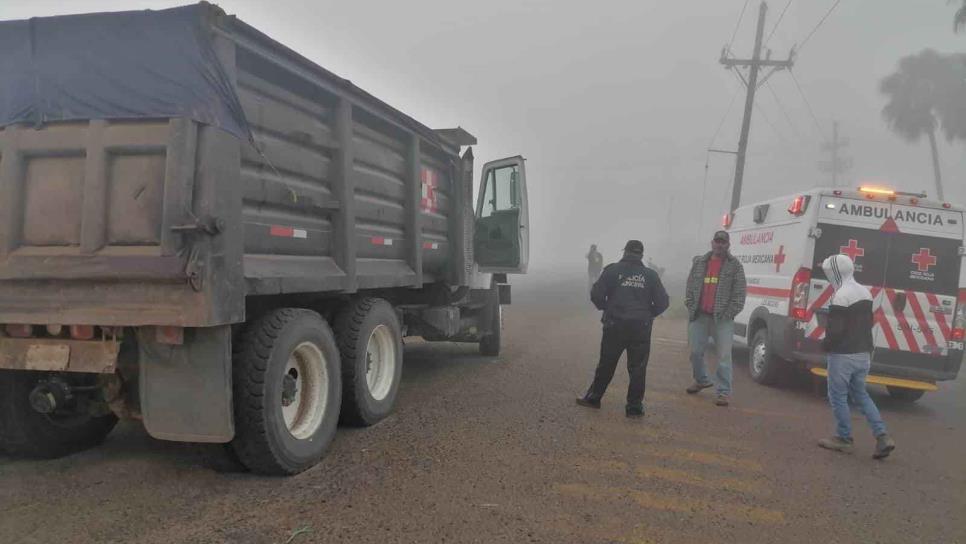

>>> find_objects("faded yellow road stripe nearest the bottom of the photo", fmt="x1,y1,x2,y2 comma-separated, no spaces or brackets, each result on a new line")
554,483,785,524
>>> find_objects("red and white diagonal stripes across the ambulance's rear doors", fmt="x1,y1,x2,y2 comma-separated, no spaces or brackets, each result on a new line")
805,285,955,355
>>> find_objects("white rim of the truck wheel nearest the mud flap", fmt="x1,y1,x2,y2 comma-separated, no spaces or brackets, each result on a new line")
280,342,329,440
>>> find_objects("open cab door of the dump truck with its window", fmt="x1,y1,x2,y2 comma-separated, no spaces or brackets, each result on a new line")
473,156,530,274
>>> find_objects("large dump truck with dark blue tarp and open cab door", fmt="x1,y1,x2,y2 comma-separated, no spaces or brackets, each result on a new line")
0,2,529,475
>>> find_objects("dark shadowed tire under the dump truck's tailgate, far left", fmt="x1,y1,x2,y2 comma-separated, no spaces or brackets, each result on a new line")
0,370,117,459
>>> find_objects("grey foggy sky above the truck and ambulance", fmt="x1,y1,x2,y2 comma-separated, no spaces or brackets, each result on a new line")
0,0,966,272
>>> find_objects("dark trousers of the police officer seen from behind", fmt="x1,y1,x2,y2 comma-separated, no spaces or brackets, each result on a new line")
587,321,651,408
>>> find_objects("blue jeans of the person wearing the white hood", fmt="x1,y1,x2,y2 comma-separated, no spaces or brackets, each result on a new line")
828,353,886,440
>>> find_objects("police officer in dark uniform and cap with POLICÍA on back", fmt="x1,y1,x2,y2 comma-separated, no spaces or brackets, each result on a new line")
577,240,668,417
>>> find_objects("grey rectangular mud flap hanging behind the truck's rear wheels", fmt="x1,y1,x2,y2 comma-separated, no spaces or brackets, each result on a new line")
138,325,235,442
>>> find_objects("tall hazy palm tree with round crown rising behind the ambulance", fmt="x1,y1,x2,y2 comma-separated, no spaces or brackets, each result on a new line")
879,50,966,200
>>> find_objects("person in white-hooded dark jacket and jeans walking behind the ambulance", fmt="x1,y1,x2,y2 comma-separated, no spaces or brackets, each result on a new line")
818,255,896,459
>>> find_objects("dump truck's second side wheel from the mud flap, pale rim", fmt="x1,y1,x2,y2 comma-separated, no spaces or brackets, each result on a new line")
335,298,403,427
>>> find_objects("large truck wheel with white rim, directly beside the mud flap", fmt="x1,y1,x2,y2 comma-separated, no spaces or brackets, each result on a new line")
231,308,342,476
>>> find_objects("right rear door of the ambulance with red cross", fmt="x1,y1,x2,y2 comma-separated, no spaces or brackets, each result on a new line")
874,203,963,374
